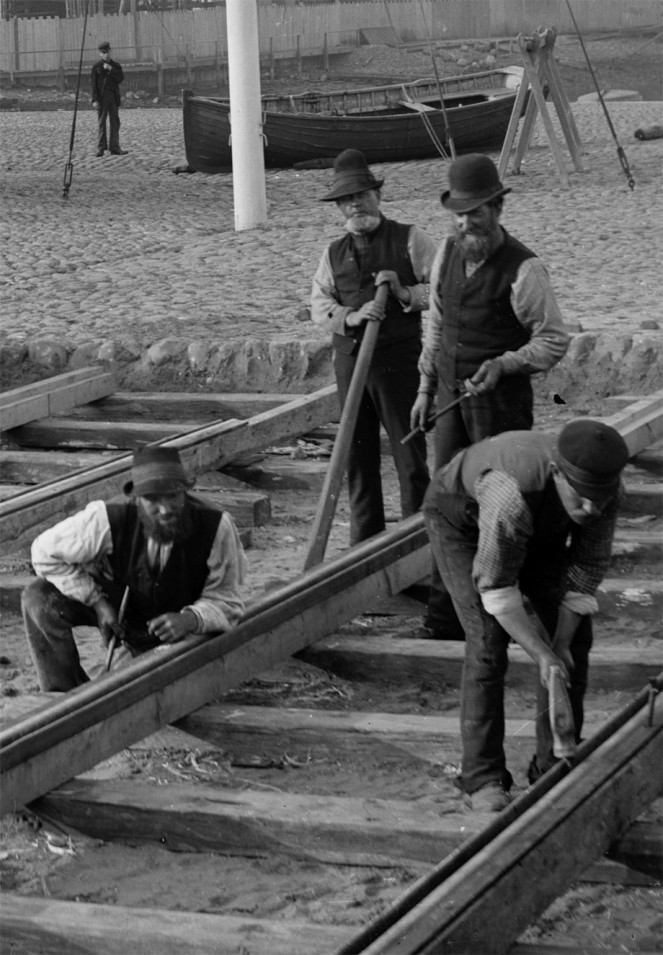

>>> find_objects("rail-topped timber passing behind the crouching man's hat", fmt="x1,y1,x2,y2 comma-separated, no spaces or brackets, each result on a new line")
0,385,338,550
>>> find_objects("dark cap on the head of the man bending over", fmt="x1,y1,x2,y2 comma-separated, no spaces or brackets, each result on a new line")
557,418,629,501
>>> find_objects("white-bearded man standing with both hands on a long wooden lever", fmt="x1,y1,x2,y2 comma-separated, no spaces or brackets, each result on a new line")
311,149,435,544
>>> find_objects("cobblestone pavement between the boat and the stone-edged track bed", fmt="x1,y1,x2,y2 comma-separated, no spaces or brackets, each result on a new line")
0,102,663,388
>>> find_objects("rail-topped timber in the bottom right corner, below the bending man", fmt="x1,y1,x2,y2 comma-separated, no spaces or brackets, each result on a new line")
342,696,663,955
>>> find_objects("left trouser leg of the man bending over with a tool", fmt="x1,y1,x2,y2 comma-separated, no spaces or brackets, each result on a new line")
423,490,512,794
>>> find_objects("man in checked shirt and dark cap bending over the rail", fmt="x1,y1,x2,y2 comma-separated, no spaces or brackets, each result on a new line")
423,418,629,812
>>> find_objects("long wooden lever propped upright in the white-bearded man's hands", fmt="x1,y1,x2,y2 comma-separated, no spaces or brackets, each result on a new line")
304,282,389,570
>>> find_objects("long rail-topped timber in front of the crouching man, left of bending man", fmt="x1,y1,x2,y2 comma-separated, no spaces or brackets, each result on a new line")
0,515,430,813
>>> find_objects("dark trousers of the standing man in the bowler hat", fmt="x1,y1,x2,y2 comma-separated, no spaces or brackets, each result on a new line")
424,375,534,640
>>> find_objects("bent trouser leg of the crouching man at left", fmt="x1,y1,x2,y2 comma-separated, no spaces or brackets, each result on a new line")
21,577,97,691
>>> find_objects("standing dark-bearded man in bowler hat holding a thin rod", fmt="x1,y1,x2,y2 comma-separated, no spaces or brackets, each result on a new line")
411,153,569,639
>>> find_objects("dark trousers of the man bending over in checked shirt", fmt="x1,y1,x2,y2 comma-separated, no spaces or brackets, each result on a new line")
423,490,592,793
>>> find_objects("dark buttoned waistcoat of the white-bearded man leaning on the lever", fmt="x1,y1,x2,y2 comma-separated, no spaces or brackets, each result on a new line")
329,217,421,352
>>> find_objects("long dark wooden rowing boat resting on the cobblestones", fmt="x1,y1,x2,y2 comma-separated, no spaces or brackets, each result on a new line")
182,66,523,173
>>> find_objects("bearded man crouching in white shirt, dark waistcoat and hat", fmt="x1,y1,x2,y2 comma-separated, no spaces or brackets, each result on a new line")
21,446,246,692
